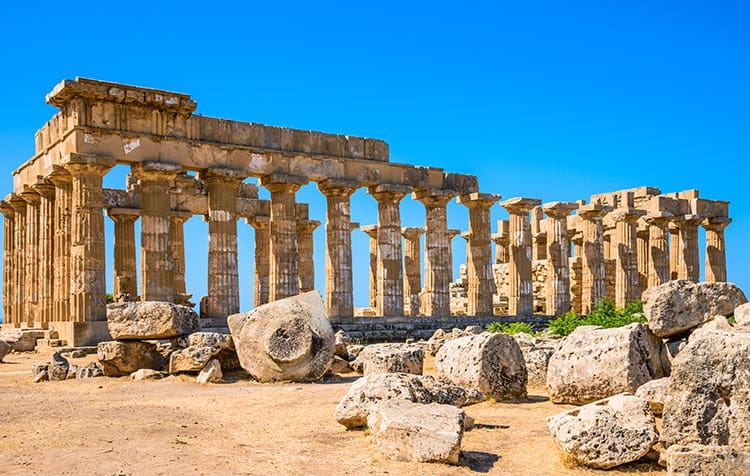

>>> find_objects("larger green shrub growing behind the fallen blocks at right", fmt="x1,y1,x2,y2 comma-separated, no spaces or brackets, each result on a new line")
548,299,646,336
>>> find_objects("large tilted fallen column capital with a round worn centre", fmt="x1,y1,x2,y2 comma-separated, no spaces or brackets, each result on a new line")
227,291,335,382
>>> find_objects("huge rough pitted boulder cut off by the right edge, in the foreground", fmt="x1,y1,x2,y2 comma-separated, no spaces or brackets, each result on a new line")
662,328,750,451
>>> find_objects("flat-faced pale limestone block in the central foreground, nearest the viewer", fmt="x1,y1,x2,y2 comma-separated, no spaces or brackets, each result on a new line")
367,400,465,464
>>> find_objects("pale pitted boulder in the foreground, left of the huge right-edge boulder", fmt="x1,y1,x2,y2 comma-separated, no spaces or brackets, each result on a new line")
547,395,658,469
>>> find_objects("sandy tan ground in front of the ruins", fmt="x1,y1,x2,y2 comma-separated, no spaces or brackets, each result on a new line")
0,354,663,476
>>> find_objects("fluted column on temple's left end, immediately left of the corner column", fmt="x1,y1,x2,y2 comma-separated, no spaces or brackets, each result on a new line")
50,168,73,322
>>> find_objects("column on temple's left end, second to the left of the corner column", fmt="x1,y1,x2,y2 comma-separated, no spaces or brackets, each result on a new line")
33,182,55,323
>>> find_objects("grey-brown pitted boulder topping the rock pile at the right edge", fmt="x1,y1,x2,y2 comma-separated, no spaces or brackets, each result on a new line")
643,280,747,337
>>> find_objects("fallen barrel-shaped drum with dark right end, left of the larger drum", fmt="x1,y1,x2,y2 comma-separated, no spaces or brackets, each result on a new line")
435,332,528,401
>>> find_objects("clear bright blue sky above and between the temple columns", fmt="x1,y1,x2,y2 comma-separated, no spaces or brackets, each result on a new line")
0,1,750,316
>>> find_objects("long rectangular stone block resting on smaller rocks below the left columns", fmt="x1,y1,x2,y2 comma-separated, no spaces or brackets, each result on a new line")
107,301,200,340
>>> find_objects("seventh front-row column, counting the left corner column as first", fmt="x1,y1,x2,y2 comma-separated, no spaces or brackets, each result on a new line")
414,190,453,316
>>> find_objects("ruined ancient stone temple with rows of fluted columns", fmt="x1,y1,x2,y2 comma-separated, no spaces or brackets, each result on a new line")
0,78,731,345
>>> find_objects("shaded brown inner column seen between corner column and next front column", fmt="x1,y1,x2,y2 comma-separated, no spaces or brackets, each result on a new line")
107,208,141,301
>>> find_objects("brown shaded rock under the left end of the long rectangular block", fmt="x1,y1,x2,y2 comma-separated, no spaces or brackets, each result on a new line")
96,341,165,377
